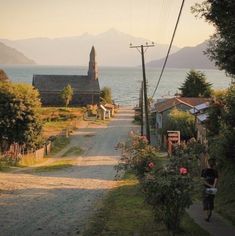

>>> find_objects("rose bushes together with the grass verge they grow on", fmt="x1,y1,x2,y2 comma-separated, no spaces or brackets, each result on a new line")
84,133,209,235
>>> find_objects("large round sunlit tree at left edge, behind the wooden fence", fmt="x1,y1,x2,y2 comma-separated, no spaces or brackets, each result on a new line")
0,82,42,151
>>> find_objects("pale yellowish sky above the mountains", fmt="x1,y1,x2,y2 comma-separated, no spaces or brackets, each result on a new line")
0,0,214,47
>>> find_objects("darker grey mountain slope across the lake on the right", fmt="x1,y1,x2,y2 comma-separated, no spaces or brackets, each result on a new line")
146,41,216,69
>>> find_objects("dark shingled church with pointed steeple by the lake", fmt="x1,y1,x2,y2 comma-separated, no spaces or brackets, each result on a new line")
33,46,100,106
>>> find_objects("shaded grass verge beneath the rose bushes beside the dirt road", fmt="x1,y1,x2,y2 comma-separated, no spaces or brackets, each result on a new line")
83,173,209,236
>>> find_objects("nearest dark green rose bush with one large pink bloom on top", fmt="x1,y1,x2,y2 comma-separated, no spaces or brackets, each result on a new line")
143,158,193,234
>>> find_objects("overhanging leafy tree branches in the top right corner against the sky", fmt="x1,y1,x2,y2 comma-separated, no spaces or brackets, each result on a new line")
192,0,235,76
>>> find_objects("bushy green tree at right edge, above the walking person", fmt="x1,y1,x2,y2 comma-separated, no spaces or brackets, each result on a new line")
207,85,235,160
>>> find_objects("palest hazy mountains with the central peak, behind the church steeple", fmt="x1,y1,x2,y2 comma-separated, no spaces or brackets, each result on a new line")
0,29,179,66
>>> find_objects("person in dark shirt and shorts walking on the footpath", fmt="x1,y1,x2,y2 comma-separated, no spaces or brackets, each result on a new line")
201,159,218,222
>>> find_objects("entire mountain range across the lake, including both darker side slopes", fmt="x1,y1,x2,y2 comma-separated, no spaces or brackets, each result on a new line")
0,29,215,69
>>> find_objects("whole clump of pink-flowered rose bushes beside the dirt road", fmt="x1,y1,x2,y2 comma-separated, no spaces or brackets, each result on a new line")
117,134,197,234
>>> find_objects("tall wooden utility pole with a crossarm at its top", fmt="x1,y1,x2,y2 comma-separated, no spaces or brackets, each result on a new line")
130,42,155,143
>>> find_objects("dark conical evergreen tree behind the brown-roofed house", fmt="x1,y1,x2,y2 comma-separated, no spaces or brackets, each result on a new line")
179,70,212,97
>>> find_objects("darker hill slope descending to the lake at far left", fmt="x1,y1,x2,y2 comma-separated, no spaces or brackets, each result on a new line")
0,42,35,65
